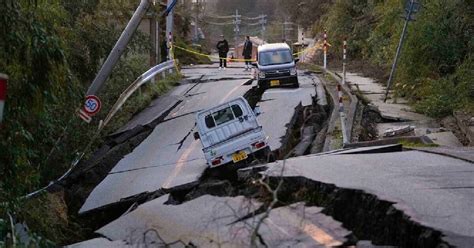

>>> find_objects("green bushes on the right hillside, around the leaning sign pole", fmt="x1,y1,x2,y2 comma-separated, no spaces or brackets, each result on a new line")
316,0,474,117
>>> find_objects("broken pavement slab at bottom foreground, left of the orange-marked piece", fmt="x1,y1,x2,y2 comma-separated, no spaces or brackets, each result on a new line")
97,195,261,247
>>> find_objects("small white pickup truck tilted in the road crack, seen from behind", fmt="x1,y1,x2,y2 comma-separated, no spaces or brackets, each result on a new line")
194,97,270,168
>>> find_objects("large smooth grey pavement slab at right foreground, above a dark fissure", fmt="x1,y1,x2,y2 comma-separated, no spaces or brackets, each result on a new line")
263,151,474,247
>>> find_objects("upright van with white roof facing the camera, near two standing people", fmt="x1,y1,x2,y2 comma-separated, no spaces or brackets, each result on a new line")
253,43,299,88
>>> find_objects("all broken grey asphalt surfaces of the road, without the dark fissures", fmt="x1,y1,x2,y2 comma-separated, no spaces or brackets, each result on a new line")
70,64,473,247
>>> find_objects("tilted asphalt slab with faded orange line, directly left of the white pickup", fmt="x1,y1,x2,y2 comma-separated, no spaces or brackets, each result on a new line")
79,116,207,213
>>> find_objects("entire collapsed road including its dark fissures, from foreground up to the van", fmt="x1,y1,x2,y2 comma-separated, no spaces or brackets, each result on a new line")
63,64,473,247
